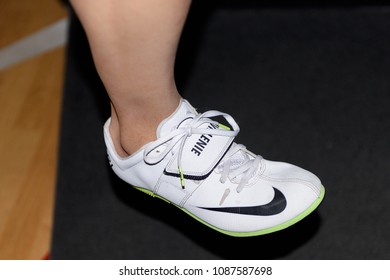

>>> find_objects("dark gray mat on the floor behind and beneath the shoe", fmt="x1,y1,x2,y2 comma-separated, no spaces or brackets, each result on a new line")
51,1,390,259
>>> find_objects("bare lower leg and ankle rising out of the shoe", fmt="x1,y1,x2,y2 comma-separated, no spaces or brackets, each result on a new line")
71,0,191,157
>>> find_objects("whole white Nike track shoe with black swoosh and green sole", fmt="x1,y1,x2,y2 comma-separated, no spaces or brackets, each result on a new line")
104,99,325,236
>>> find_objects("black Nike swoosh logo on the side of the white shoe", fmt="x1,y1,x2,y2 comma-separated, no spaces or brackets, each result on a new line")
200,187,287,216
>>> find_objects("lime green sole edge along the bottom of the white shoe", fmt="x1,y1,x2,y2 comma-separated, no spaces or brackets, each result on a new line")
134,186,325,237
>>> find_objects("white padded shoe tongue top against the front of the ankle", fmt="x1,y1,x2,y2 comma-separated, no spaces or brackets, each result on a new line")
157,99,197,138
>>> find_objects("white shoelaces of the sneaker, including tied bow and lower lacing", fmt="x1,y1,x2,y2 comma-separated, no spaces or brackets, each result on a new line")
144,111,261,192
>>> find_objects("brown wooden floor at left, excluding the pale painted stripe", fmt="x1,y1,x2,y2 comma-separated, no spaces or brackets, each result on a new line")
0,0,67,259
